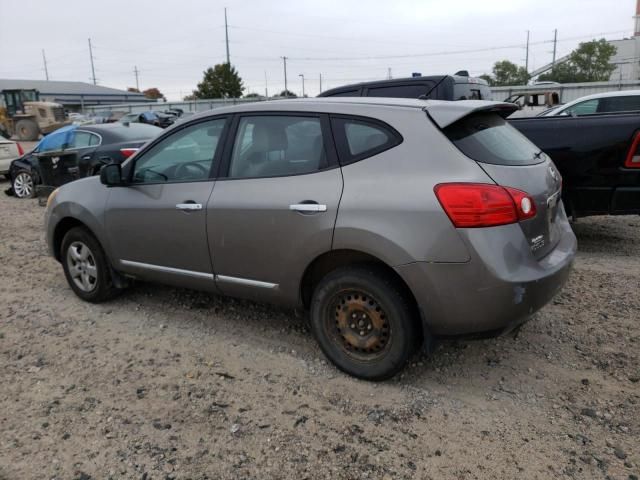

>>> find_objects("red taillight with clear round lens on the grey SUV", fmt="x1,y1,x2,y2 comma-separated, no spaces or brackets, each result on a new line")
434,183,536,228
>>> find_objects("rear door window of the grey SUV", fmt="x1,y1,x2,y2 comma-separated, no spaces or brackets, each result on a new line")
229,115,327,178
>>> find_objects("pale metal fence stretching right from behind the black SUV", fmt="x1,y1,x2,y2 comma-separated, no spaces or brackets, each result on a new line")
491,80,640,103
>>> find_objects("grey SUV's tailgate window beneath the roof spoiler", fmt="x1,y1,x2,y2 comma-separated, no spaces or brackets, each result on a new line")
444,113,544,166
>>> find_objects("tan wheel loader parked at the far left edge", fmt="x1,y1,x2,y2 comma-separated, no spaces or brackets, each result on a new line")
0,90,71,141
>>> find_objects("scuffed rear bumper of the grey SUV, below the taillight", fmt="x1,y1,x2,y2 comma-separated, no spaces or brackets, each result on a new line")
395,205,577,336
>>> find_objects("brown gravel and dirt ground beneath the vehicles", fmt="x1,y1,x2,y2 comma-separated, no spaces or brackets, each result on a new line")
0,182,640,480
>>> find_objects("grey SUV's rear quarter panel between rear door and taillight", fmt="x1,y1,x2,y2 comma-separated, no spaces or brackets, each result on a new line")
333,109,493,266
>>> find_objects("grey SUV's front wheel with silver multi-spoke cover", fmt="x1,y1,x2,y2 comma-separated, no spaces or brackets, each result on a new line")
60,227,120,303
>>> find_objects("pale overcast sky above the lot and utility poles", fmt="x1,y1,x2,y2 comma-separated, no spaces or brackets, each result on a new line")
0,0,636,100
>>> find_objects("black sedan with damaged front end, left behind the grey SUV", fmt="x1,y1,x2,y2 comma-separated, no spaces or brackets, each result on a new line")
8,123,162,198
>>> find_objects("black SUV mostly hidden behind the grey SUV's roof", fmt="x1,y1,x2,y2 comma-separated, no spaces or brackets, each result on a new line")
318,71,493,100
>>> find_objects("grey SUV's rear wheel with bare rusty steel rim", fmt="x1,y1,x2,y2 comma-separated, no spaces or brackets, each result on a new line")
310,265,422,381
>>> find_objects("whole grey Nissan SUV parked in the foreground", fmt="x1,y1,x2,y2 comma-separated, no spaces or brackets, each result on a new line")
46,98,576,380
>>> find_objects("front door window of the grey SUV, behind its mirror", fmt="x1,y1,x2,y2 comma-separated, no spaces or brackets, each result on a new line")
133,119,225,183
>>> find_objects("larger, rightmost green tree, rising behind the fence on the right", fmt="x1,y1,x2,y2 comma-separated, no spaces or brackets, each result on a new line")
538,38,617,83
